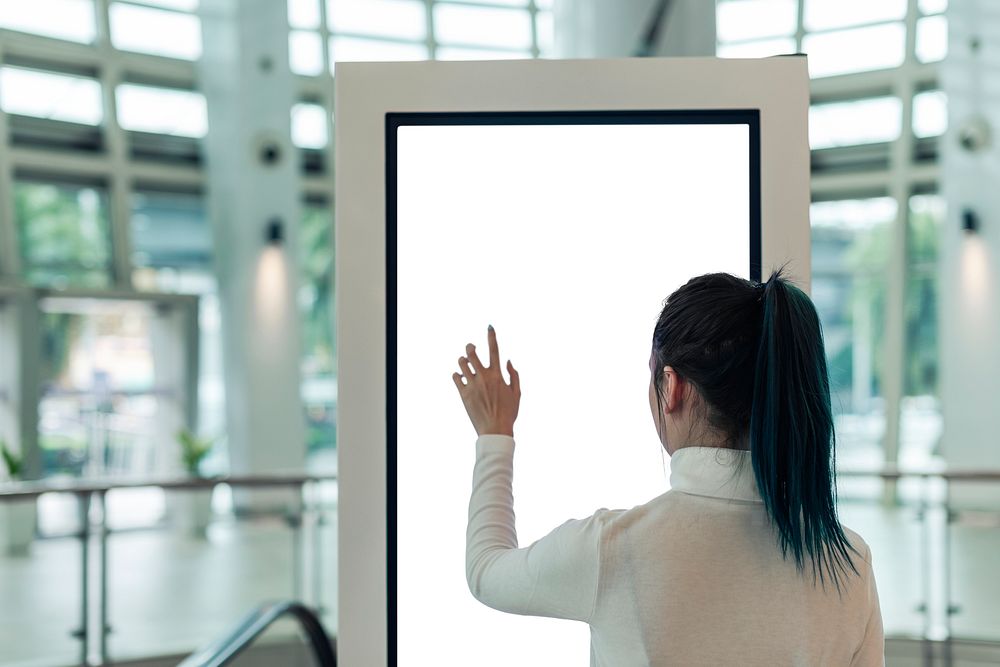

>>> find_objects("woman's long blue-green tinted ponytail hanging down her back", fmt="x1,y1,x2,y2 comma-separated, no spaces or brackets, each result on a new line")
749,271,857,590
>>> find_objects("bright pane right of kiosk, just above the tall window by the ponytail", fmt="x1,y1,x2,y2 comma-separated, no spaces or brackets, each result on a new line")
809,97,903,149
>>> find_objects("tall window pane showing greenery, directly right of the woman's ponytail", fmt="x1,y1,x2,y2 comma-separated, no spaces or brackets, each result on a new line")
810,197,896,466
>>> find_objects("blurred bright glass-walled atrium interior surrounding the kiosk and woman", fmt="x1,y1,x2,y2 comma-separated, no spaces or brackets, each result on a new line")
0,0,1000,665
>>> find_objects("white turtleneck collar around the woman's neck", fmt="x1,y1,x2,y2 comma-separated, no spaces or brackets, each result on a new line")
670,447,762,502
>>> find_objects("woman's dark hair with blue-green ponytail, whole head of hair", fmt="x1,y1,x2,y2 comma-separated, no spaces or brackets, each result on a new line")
653,271,857,590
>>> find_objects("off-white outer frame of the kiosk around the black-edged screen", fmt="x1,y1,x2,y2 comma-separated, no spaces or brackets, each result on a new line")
335,57,810,667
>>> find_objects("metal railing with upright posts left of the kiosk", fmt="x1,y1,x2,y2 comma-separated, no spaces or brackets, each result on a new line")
0,474,337,665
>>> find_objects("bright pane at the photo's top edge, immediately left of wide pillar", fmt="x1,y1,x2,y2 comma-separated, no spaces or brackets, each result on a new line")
110,3,201,60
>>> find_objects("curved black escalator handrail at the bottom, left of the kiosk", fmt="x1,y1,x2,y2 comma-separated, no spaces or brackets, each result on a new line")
178,601,337,667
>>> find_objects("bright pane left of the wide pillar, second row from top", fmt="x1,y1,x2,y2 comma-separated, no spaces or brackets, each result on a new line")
116,83,208,137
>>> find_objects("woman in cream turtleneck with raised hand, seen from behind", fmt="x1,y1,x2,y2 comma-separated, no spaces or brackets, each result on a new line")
453,272,884,667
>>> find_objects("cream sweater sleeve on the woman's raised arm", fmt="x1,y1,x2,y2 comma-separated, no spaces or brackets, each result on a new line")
465,435,608,622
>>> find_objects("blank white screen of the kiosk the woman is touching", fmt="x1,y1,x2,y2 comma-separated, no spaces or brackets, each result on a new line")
390,124,750,667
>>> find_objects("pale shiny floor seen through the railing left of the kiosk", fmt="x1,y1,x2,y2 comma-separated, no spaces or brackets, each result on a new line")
0,520,337,667
